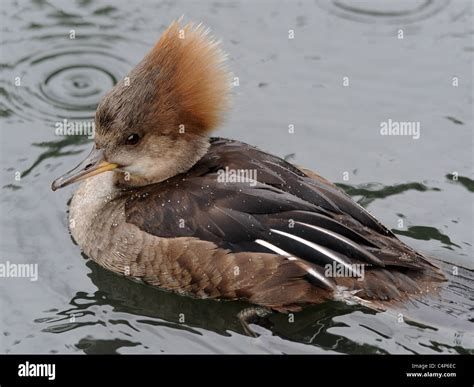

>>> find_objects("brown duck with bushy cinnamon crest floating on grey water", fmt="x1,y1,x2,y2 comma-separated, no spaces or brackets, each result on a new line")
52,20,445,330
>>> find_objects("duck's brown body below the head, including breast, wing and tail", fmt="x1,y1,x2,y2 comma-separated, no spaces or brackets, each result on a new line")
70,139,443,310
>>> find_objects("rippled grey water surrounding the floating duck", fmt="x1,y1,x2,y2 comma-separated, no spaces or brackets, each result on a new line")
0,0,474,353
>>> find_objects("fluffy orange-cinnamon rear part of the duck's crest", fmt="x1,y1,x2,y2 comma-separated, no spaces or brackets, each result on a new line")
144,18,230,133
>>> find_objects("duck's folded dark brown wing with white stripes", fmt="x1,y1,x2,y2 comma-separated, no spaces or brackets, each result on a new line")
125,139,442,302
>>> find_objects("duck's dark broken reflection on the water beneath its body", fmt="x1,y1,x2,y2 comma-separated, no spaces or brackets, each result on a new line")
41,261,375,353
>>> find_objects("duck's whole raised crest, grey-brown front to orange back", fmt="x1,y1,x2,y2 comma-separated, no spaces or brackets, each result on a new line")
96,18,231,139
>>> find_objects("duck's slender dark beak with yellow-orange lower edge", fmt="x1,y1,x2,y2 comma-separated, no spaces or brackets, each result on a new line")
51,147,118,191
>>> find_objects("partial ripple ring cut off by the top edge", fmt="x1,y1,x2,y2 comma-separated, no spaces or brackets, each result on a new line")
318,0,449,24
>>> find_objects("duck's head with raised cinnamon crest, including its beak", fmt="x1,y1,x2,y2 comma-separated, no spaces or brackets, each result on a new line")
52,21,230,190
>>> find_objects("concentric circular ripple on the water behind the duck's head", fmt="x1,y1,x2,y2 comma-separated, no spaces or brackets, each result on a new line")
0,38,143,121
